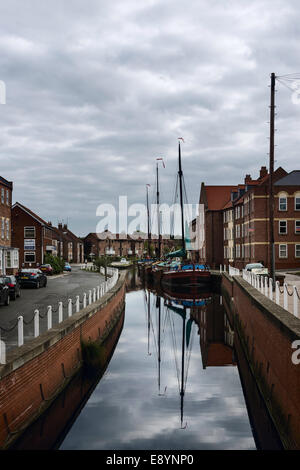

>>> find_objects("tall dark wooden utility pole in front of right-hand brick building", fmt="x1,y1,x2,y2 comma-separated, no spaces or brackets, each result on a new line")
269,73,276,289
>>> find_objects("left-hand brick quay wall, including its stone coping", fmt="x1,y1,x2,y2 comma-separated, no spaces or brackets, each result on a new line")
0,272,126,449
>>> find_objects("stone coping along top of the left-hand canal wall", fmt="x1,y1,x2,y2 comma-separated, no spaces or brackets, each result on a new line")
0,271,127,379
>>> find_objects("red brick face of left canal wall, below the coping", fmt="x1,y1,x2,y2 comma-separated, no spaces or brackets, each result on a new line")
0,284,125,447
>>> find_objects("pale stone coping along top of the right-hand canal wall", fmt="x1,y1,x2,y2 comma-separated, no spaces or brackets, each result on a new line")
223,273,300,341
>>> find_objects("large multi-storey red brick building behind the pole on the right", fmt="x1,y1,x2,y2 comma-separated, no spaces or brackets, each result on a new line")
191,167,300,270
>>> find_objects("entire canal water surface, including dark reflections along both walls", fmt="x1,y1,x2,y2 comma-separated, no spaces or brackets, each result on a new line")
8,274,280,450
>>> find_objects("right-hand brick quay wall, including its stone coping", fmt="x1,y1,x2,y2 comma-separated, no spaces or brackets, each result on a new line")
220,273,300,450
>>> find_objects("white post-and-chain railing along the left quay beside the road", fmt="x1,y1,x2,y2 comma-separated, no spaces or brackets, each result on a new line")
0,268,119,364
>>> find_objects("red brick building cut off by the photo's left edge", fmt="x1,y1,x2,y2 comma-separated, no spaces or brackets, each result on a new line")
0,177,19,274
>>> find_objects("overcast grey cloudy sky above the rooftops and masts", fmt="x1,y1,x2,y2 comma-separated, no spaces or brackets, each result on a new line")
0,0,300,235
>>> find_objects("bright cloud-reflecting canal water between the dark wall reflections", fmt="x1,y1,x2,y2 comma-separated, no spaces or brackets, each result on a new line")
60,290,256,450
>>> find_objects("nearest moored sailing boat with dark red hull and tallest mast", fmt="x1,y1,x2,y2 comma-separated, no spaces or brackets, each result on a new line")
152,137,211,286
